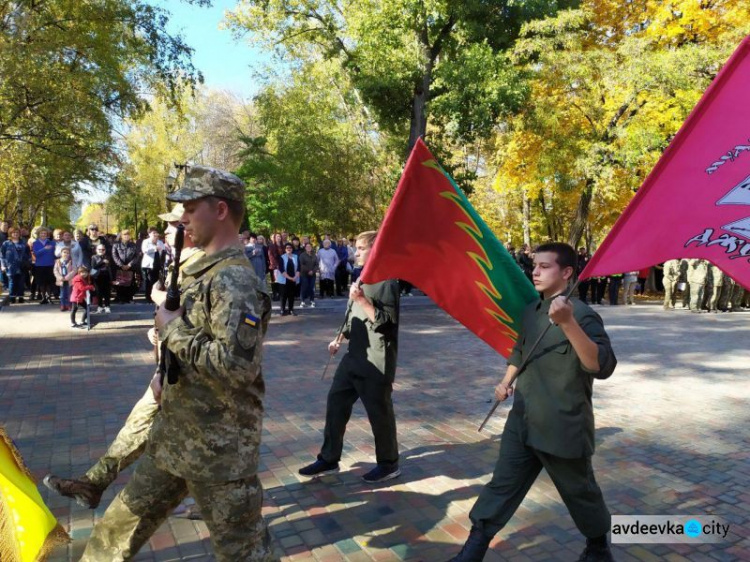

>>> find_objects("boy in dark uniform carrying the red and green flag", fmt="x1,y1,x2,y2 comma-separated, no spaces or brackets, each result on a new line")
299,232,401,482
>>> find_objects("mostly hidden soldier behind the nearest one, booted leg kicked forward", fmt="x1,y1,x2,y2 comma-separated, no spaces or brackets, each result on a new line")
44,204,203,508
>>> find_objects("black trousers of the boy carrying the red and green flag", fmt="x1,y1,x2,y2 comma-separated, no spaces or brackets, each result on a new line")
318,357,398,464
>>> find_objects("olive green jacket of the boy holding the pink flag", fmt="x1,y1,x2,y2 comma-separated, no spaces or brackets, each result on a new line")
508,297,617,459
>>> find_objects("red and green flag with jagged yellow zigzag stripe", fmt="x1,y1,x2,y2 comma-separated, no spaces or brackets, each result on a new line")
362,139,539,357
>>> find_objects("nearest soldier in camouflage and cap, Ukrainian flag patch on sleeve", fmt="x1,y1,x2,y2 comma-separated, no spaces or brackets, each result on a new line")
81,166,277,562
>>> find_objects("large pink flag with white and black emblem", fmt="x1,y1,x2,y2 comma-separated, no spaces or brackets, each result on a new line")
581,37,750,289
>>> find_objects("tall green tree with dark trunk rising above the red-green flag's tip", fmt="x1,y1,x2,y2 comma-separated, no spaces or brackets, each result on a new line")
229,0,567,152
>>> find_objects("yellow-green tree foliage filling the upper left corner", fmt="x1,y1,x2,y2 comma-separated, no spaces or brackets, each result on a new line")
0,0,207,226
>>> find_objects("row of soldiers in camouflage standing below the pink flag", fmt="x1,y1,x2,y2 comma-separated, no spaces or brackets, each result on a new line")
664,259,750,312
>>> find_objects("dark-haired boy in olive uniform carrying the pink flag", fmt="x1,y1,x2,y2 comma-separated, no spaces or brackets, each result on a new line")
452,243,617,562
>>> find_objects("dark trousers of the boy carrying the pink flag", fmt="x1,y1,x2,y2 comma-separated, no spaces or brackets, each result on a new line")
469,412,612,539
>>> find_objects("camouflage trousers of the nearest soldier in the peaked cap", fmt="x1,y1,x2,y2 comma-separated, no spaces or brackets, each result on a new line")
81,455,278,562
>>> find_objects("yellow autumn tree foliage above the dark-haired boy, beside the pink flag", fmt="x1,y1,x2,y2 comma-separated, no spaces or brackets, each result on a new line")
496,0,750,245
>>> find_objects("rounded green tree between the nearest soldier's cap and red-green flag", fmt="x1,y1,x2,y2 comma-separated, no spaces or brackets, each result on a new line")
237,63,397,234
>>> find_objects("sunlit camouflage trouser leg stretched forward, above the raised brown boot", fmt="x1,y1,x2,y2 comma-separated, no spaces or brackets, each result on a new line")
86,386,159,490
